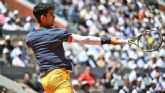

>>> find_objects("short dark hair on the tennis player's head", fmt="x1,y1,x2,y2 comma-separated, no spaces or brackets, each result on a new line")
33,3,54,22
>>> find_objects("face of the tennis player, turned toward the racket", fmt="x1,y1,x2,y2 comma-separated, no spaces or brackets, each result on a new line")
45,10,55,26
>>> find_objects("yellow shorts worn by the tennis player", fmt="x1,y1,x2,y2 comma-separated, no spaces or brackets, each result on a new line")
41,68,73,93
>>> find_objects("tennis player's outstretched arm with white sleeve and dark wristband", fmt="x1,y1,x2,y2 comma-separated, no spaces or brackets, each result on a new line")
67,34,128,45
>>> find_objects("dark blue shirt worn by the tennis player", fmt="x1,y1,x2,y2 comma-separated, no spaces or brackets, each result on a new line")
26,28,72,75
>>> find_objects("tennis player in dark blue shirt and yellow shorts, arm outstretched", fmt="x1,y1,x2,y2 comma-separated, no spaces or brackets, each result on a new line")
26,3,127,93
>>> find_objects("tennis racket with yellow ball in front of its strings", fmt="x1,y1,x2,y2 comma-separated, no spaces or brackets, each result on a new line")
128,30,163,52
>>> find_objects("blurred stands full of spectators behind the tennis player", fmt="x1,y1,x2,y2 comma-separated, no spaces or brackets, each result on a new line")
0,0,165,93
